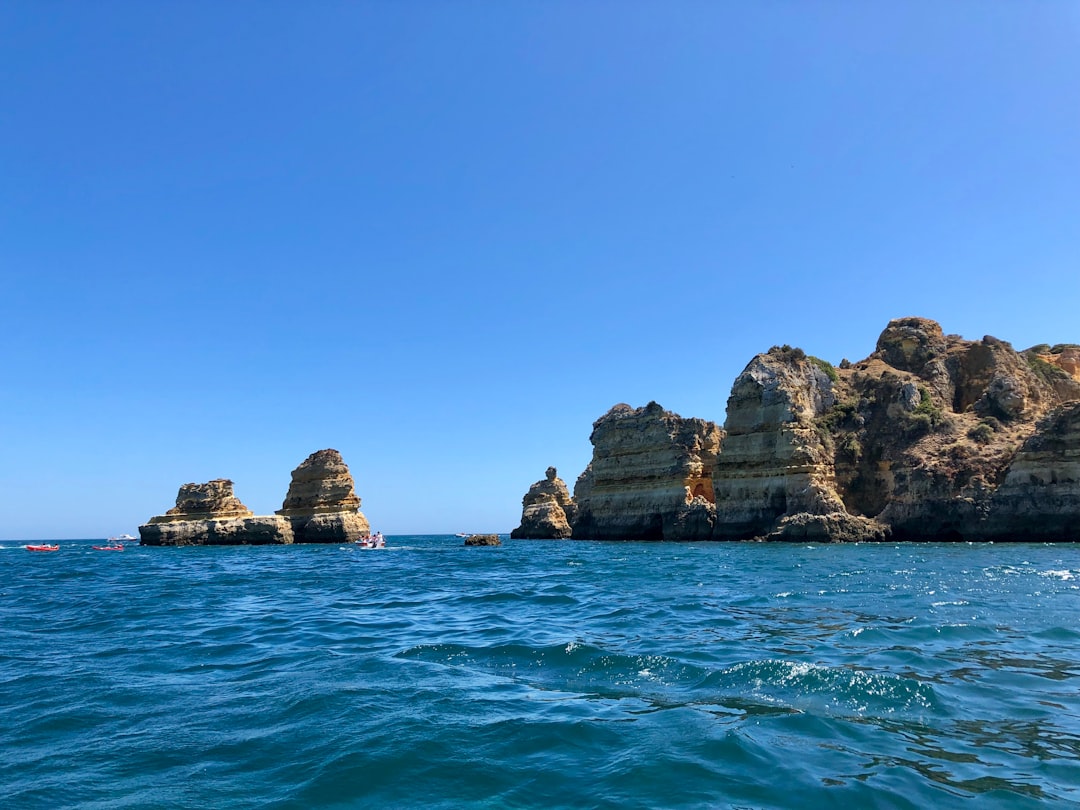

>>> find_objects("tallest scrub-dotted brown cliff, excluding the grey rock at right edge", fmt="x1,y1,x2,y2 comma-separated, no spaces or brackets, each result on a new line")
714,318,1080,540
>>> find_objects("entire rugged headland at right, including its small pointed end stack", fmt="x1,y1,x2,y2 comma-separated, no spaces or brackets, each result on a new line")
512,318,1080,542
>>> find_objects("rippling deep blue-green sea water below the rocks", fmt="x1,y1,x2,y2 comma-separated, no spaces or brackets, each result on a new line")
0,537,1080,810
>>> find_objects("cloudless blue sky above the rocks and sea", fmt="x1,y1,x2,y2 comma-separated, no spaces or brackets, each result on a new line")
0,0,1080,539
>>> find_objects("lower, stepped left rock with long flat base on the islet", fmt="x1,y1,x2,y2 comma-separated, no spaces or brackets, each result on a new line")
138,478,293,545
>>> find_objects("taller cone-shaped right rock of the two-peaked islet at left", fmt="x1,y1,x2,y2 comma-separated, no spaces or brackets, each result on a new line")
276,449,372,543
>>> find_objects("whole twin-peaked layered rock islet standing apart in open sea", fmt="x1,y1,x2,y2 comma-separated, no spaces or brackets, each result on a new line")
138,449,370,545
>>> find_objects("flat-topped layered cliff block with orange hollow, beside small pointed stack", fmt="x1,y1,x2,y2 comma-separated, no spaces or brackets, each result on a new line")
572,402,721,540
